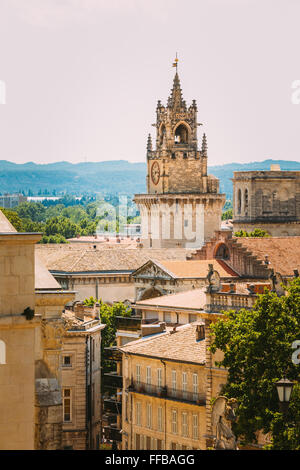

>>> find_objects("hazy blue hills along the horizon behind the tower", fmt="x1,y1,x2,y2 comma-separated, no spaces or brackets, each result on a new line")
0,160,300,198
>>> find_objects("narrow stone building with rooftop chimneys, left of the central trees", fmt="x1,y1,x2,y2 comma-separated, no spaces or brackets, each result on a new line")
61,307,105,450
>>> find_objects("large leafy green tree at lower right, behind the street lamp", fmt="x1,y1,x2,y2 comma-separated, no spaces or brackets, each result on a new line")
211,278,300,450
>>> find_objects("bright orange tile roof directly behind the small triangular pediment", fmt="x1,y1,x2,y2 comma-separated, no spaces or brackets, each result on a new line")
156,256,238,279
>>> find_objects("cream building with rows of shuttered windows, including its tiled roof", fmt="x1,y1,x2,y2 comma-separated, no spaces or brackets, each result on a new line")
121,325,206,450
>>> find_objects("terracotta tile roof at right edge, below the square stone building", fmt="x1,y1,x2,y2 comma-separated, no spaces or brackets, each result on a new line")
236,237,300,276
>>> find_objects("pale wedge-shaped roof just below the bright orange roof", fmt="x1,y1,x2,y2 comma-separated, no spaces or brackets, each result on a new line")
136,288,206,310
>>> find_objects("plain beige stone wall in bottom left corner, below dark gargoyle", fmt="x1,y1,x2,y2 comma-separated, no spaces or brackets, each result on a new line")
0,316,38,450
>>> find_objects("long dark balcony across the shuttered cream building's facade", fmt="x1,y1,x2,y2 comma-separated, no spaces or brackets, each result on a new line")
128,382,206,405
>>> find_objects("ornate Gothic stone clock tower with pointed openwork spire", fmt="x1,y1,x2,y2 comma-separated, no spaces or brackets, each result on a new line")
134,63,225,252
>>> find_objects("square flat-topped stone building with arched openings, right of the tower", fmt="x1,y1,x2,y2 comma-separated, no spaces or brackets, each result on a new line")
232,165,300,237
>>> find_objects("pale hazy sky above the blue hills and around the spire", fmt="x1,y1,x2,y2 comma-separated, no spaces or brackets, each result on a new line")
0,0,300,165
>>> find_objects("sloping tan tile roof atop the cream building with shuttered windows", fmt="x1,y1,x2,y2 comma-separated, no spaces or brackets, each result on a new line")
120,322,206,365
